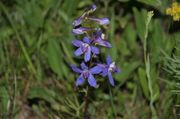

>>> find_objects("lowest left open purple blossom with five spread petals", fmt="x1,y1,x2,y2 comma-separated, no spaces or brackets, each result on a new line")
71,63,101,88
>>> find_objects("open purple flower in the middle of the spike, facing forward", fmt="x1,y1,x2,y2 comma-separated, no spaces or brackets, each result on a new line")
72,36,99,62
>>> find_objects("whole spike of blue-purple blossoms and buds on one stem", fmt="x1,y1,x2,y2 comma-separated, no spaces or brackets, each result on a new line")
71,5,120,87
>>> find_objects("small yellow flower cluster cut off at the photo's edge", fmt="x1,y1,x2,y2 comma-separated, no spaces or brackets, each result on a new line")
166,2,180,21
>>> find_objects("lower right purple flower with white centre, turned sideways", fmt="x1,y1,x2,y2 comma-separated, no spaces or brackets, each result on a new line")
97,56,120,86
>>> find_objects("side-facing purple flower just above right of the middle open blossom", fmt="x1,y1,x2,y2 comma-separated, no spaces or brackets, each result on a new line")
93,30,112,48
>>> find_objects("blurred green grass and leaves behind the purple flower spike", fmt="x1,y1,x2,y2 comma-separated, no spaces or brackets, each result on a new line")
0,0,180,119
